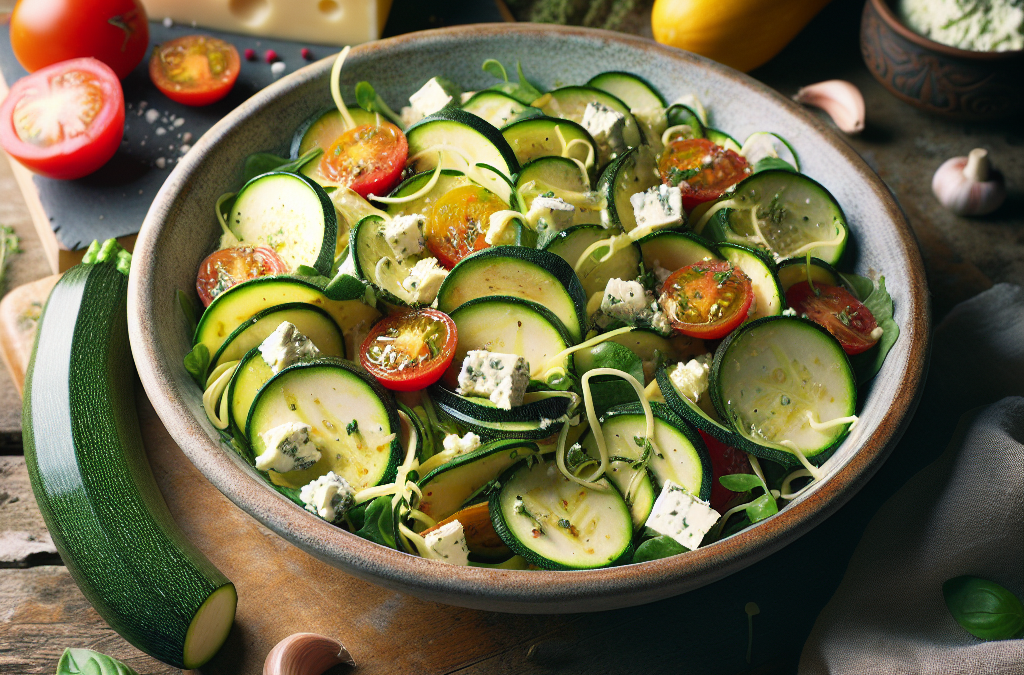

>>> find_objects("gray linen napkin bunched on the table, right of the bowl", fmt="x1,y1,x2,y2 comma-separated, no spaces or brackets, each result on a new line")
800,284,1024,675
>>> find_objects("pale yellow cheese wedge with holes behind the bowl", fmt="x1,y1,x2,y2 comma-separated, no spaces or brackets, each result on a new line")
142,0,391,46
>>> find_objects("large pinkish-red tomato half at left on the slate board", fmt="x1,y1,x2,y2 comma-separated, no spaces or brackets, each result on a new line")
0,58,125,179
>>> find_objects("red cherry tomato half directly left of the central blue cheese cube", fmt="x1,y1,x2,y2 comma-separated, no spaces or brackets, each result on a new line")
359,309,459,391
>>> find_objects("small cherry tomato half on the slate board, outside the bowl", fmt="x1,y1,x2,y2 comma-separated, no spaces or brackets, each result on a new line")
150,35,242,106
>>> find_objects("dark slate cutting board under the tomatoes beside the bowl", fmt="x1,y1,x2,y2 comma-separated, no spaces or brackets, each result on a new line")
0,0,508,271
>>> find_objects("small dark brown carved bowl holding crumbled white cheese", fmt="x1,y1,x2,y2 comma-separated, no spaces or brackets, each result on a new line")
860,0,1024,122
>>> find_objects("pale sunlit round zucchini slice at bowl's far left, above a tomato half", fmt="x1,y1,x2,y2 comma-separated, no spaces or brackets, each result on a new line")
227,171,338,277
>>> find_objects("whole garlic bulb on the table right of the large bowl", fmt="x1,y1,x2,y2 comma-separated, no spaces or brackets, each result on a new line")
932,147,1007,216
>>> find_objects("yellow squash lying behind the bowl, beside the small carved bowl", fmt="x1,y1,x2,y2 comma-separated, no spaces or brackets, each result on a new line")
650,0,828,72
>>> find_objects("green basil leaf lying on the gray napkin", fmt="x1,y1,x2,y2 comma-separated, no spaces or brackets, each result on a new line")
942,577,1024,640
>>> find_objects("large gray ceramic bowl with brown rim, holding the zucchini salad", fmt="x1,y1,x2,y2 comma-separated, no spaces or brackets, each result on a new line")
129,25,929,613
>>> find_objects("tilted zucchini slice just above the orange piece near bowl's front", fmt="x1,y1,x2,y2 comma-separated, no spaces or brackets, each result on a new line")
419,439,540,521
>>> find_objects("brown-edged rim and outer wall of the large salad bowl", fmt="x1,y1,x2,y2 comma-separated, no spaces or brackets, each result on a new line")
128,24,931,614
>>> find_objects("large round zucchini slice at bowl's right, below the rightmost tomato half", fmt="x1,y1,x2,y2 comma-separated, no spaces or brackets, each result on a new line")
711,317,857,466
